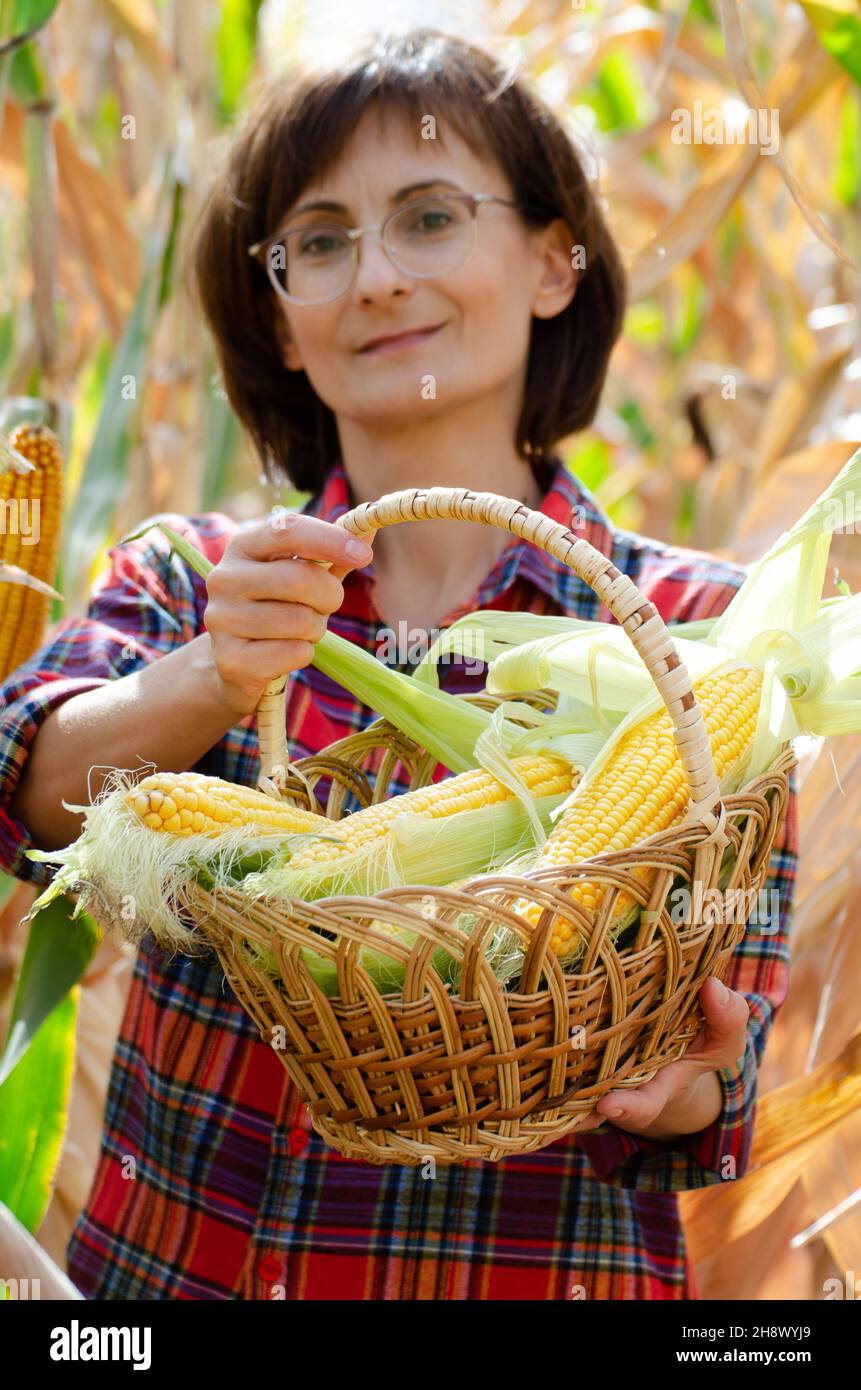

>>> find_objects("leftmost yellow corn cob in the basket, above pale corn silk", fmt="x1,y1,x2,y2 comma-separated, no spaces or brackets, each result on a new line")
125,773,332,835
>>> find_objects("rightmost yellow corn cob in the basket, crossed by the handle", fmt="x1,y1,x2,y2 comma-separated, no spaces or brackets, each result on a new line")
516,666,762,959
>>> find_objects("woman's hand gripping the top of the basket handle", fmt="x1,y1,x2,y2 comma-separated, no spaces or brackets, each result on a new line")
204,510,376,717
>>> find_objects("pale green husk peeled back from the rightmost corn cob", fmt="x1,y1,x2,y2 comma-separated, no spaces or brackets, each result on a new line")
487,449,861,816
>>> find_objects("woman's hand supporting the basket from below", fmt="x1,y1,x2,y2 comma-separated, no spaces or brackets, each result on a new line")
577,977,750,1140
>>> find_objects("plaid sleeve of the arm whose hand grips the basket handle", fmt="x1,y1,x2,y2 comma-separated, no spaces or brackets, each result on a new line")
0,513,226,887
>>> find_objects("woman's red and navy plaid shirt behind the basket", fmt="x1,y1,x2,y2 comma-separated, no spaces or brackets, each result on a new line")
0,460,797,1300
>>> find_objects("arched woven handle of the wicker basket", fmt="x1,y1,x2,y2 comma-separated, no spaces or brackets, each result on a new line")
257,488,725,842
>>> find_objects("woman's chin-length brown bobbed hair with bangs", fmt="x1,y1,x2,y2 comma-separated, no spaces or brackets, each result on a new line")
191,28,626,492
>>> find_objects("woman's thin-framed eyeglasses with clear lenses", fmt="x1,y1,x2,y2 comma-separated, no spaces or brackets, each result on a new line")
248,193,524,304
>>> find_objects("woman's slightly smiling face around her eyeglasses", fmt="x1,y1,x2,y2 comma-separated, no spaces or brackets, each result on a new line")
273,111,576,428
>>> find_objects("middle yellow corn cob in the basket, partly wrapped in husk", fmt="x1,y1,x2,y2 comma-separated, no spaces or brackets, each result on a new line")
291,753,579,869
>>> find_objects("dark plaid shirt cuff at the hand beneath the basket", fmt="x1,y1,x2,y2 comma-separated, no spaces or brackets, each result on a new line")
577,1034,757,1193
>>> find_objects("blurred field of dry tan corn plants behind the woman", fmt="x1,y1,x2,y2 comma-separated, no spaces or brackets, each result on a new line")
0,0,861,1298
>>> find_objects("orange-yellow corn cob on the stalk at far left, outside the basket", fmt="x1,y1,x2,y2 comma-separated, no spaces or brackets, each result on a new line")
0,424,63,680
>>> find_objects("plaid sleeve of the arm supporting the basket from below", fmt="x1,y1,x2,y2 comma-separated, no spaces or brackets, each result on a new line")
577,564,798,1193
